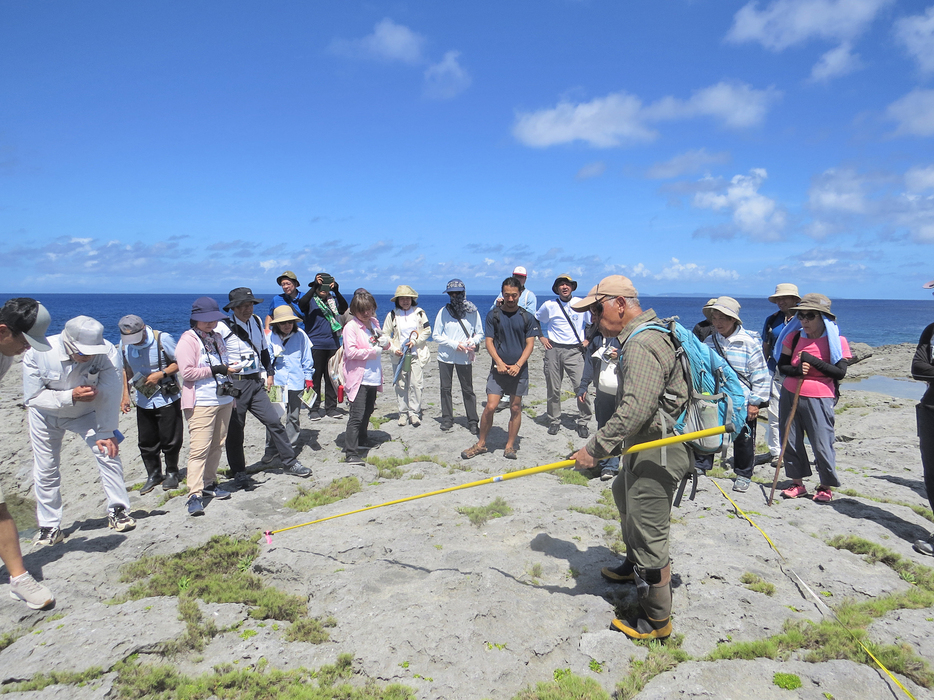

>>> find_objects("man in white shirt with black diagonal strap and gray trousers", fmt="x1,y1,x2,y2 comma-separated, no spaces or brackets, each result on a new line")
535,275,593,438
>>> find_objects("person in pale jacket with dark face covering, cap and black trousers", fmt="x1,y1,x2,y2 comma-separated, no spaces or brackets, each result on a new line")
432,279,484,435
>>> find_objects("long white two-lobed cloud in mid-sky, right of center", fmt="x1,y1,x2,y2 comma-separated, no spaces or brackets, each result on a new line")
513,82,781,148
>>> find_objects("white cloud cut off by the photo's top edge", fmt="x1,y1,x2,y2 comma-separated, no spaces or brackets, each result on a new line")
726,0,892,51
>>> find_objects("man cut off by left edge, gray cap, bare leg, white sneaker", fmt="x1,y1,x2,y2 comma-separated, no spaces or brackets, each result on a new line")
0,297,55,610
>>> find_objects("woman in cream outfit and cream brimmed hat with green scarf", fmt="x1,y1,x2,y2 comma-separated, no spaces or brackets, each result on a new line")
383,284,431,427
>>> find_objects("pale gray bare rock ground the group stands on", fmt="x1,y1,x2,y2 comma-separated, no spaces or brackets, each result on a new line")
0,346,934,700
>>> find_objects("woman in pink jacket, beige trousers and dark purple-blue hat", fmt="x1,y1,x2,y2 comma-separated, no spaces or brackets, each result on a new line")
175,297,239,515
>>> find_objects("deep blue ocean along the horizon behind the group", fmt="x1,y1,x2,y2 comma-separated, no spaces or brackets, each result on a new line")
0,290,934,346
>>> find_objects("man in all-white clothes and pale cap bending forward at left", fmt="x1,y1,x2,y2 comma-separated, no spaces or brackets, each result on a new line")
23,316,136,545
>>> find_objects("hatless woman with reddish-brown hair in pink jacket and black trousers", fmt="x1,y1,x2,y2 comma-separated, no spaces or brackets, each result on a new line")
343,289,389,464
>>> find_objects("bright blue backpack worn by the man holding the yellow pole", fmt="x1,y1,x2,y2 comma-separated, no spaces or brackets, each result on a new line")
620,316,746,454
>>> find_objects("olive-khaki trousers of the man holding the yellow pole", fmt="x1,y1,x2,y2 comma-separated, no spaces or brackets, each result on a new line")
613,435,693,569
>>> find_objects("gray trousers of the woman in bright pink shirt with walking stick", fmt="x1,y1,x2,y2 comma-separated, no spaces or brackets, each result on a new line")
779,389,840,487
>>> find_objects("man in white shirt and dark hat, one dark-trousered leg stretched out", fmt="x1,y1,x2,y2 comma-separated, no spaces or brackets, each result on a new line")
217,287,311,488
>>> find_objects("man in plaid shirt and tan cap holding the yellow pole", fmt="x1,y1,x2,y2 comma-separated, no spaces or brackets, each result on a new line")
571,275,692,639
